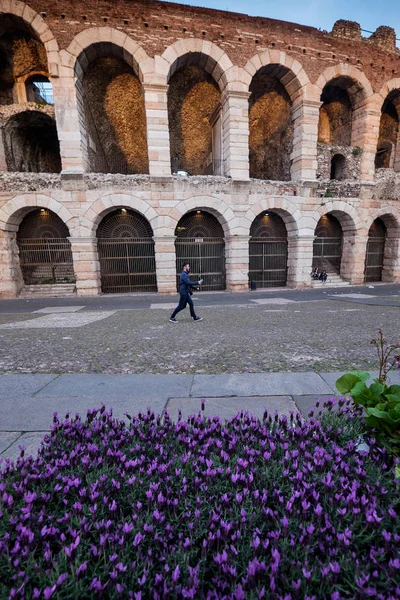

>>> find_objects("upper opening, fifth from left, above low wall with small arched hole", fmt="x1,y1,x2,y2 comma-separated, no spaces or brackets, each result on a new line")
318,76,354,146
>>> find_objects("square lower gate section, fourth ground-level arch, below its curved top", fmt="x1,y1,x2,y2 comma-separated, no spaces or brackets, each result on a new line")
249,237,288,288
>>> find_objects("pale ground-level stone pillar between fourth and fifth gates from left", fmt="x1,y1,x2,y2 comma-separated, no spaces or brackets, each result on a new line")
287,235,315,288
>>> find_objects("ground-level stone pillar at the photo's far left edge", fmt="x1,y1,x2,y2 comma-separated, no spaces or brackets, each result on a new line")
0,231,24,298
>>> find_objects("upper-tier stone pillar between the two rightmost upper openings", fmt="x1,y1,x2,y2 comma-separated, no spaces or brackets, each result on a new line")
351,104,381,181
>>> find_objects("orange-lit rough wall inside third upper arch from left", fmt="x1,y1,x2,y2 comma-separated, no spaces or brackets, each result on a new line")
168,66,220,175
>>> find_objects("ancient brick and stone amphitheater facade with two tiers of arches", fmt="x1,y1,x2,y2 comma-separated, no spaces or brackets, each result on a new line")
0,0,400,298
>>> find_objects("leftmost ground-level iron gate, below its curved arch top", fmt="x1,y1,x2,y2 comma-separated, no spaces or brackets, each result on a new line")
18,238,76,285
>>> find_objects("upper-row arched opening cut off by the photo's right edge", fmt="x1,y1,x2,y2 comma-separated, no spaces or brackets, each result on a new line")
375,90,400,171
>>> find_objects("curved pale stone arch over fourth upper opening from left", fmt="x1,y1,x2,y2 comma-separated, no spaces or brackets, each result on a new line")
244,50,310,102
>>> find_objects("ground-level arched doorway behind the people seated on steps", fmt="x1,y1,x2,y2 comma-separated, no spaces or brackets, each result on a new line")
313,214,343,274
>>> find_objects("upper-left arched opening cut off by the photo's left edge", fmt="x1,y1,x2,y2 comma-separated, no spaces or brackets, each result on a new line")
0,14,48,105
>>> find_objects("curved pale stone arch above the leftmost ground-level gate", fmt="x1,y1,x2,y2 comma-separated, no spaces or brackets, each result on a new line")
0,194,76,235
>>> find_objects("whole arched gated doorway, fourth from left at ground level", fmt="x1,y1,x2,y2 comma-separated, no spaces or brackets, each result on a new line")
249,210,288,288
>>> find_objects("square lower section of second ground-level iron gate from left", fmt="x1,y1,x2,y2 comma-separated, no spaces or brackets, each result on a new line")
97,237,157,294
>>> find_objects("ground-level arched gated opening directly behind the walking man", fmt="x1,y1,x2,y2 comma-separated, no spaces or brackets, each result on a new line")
175,210,226,291
